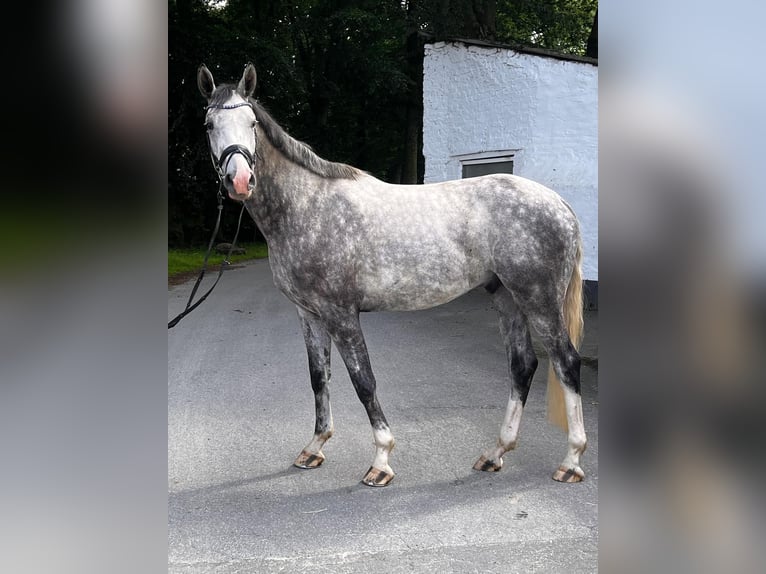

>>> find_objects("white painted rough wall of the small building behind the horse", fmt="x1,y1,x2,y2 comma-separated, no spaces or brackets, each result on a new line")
423,42,598,280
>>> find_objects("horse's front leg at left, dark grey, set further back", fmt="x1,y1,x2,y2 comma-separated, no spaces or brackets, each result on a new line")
293,308,333,468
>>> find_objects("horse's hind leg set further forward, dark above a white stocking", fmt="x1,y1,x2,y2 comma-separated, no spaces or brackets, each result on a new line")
473,286,537,471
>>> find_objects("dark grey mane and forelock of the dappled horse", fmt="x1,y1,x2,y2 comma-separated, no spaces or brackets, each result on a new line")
210,84,364,179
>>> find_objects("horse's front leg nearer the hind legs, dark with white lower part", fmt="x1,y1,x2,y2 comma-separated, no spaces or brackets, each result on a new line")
328,313,395,486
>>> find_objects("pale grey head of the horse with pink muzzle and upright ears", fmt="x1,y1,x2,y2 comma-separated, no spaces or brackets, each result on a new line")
197,64,258,201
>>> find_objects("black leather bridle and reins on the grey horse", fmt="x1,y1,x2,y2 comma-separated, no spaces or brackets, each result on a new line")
168,102,255,329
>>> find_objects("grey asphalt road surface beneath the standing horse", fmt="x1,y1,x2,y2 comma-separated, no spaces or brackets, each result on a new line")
168,260,598,574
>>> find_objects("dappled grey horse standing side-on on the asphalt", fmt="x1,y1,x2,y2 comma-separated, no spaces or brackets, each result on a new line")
197,64,587,487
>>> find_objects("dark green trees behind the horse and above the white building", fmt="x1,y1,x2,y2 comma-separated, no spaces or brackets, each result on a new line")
168,0,596,245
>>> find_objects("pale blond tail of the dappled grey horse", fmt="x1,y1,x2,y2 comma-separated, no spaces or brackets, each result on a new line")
548,237,583,431
